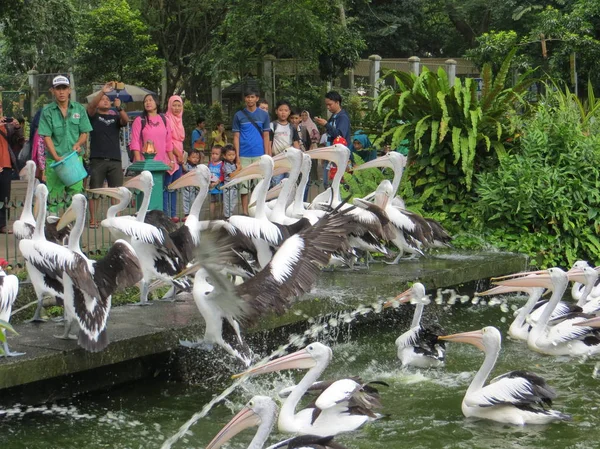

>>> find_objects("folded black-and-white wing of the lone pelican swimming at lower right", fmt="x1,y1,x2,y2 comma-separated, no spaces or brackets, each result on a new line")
464,371,556,407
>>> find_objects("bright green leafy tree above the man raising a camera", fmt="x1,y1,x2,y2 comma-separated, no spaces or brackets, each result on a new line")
76,0,162,90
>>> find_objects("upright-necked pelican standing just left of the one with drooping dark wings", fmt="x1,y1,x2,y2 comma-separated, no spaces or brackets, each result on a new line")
19,184,67,321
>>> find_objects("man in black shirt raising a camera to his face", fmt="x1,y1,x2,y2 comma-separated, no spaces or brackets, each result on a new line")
87,82,129,228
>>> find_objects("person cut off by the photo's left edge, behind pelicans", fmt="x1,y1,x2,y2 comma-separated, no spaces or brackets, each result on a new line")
0,117,25,234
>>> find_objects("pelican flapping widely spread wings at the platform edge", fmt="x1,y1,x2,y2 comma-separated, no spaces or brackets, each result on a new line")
182,206,352,364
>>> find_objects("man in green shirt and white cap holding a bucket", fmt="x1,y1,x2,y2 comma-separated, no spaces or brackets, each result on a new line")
38,75,92,212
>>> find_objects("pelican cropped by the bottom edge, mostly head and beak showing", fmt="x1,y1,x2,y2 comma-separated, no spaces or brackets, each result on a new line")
206,396,345,449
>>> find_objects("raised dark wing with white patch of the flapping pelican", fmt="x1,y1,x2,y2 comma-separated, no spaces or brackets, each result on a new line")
237,211,354,322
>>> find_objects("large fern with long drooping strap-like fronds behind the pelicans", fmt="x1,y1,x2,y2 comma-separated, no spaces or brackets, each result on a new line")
375,51,533,220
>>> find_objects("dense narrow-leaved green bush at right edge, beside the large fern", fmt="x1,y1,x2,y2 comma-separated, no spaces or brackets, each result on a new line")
474,83,600,267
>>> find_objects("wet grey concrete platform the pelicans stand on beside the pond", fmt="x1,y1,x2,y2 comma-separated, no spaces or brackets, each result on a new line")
0,252,526,403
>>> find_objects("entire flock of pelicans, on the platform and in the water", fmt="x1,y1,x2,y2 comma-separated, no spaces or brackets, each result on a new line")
0,145,600,449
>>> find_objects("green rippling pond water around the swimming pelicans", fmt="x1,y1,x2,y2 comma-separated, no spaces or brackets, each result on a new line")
0,290,600,449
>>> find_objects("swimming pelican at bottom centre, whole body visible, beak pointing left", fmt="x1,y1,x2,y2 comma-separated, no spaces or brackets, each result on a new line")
233,342,381,437
